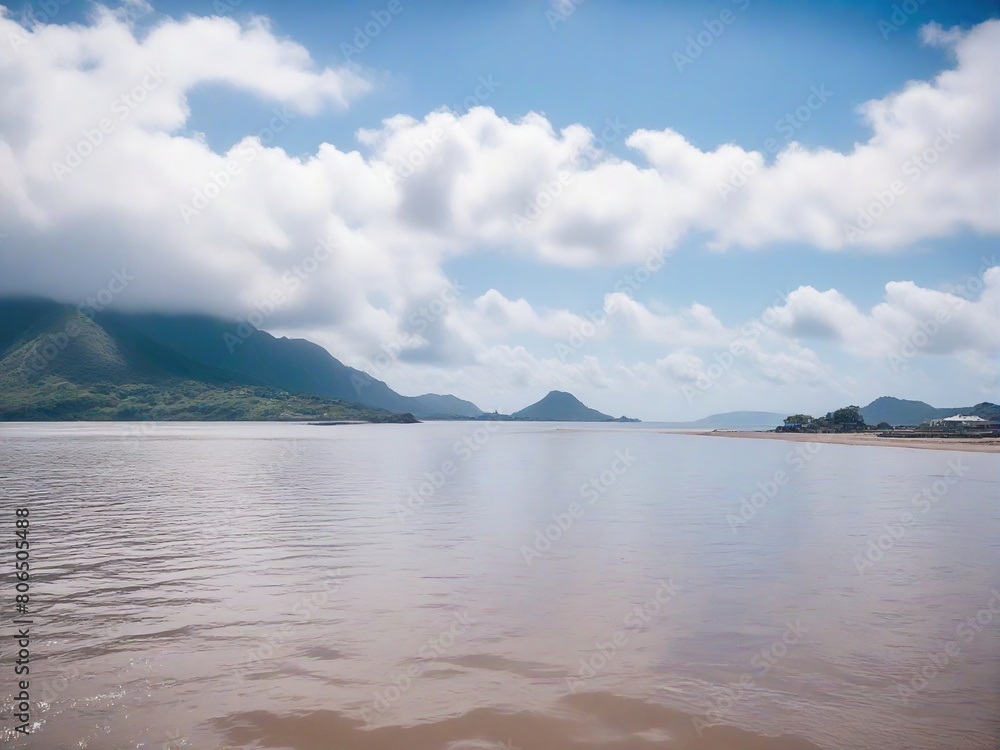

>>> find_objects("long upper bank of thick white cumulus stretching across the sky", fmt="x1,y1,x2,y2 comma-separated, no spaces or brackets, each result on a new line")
0,8,1000,310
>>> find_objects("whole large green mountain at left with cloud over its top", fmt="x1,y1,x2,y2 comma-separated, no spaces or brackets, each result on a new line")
0,299,481,421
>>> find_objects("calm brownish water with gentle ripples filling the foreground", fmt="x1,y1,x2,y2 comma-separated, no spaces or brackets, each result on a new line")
0,423,1000,750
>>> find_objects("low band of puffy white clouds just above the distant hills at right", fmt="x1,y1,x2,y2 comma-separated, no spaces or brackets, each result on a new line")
402,266,1000,412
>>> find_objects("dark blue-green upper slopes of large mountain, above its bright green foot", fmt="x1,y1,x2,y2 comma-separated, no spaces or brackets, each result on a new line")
0,298,482,424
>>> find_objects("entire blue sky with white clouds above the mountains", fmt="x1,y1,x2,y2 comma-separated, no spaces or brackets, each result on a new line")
0,0,1000,421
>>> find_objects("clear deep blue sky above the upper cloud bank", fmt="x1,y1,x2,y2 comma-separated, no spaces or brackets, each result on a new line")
150,0,997,152
